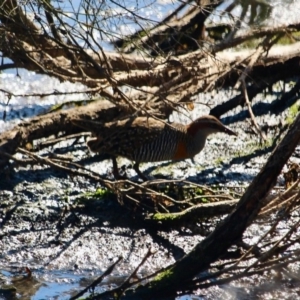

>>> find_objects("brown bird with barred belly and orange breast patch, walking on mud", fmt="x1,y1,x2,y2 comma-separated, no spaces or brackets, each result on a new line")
72,115,237,180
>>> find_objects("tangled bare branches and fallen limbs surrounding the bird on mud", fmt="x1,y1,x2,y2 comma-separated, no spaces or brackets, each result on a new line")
0,0,300,299
